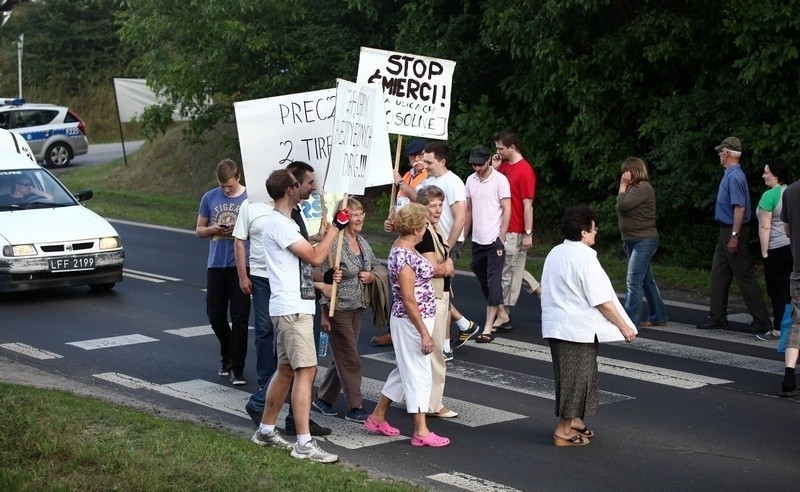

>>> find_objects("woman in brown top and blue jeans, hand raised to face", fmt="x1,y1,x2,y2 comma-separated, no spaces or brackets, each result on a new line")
616,157,667,326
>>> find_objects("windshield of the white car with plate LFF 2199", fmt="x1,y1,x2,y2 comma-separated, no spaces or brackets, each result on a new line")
0,168,78,210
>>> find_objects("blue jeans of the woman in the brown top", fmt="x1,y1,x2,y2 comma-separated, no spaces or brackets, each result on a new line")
623,236,667,326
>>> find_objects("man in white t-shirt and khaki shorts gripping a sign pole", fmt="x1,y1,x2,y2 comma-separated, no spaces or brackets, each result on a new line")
251,169,349,463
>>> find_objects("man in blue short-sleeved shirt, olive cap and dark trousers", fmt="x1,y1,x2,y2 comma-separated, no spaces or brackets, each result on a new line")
697,137,772,333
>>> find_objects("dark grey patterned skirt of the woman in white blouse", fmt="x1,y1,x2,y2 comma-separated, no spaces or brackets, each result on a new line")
547,338,600,419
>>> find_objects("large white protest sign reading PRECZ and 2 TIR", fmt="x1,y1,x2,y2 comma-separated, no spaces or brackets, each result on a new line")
234,89,336,202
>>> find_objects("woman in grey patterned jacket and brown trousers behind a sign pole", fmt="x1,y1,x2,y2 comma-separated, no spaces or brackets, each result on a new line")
312,198,378,423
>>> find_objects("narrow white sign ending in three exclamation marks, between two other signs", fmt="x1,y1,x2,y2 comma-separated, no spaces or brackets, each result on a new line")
325,79,391,195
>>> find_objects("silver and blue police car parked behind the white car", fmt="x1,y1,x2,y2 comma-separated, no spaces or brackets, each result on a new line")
0,99,89,167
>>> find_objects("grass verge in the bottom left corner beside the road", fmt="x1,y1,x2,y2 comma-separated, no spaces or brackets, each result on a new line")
0,384,419,491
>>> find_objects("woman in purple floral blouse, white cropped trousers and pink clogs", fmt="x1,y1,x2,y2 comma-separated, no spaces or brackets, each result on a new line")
364,203,450,447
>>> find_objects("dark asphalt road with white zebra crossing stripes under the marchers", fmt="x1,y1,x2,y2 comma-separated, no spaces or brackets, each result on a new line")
0,222,800,491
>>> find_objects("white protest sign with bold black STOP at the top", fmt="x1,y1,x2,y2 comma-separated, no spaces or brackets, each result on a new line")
357,47,456,140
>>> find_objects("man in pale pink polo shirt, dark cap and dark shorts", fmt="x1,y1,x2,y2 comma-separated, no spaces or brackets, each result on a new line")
464,145,511,343
